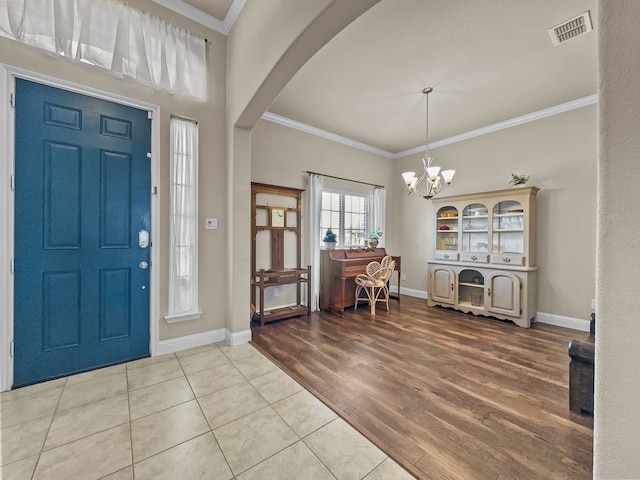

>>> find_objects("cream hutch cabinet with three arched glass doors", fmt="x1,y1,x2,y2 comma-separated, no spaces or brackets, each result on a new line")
427,187,538,327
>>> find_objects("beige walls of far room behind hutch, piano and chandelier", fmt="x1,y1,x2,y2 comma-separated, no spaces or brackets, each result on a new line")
251,106,597,320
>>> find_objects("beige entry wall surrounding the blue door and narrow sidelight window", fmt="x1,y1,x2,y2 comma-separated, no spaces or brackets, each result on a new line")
0,0,226,340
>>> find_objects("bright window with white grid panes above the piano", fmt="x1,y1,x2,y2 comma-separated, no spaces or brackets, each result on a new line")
320,189,373,247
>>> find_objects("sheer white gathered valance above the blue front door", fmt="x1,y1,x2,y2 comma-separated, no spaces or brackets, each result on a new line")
0,0,207,100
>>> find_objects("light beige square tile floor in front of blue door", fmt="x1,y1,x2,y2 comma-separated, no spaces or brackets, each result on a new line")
0,344,413,480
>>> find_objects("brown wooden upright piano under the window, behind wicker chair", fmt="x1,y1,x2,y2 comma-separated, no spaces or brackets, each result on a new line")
320,248,402,317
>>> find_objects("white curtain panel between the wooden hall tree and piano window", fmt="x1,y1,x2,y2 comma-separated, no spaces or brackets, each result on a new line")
307,174,322,312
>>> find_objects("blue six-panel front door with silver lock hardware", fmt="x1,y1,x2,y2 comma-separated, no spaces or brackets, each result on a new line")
14,79,151,387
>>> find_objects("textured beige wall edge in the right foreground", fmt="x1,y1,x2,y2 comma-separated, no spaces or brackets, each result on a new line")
594,0,640,479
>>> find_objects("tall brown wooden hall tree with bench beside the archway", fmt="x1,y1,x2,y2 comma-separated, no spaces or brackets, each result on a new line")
251,182,311,326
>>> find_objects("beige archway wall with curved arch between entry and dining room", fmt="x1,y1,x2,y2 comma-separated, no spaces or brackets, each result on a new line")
226,0,379,332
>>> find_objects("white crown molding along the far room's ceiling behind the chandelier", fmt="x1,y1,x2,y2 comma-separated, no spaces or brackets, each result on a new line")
261,94,598,160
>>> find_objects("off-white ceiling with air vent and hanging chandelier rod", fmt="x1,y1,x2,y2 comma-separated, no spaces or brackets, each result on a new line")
162,0,597,157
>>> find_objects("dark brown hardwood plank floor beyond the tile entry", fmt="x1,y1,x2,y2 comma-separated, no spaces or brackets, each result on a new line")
252,296,593,480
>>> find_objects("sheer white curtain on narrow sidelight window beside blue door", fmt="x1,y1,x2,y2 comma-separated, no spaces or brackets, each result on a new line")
165,118,202,323
